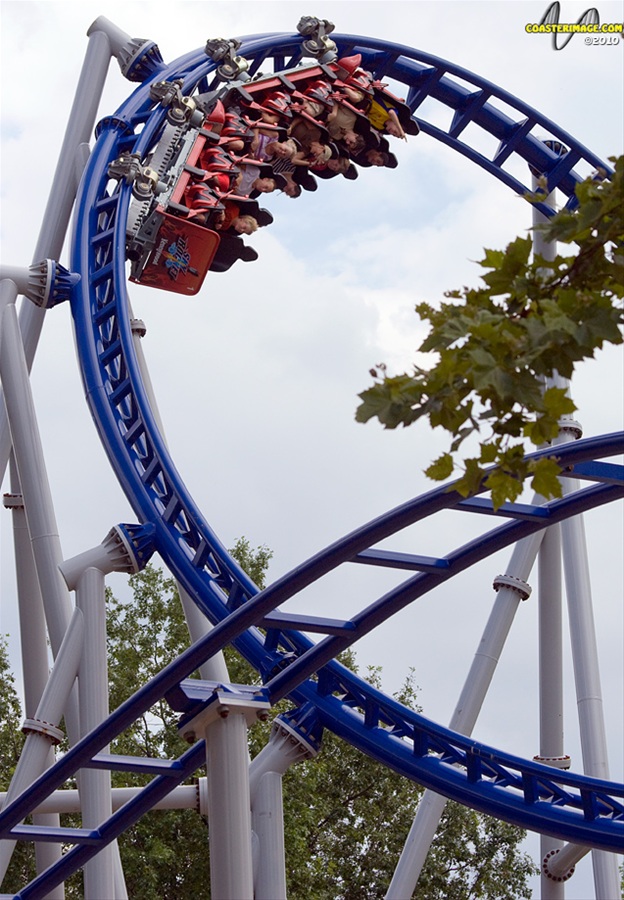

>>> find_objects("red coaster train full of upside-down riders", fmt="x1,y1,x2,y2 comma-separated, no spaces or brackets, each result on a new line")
119,41,418,294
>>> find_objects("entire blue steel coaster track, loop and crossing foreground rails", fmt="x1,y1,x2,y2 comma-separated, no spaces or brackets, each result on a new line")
0,34,624,898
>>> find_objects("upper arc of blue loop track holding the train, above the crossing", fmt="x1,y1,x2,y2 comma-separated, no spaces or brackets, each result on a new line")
73,28,620,671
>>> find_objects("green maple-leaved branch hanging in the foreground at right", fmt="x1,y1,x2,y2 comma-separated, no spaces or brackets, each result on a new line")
356,157,624,507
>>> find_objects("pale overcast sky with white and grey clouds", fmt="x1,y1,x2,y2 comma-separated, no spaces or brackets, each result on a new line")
0,0,624,900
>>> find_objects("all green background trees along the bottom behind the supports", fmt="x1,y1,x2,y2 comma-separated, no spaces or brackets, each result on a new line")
0,539,534,900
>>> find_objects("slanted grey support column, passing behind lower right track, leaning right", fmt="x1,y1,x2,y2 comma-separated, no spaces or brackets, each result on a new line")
386,532,543,900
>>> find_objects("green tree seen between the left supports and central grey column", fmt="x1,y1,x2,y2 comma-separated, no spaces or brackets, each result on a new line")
107,566,209,900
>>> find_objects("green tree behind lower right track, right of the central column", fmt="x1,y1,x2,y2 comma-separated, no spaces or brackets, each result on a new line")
284,651,537,900
